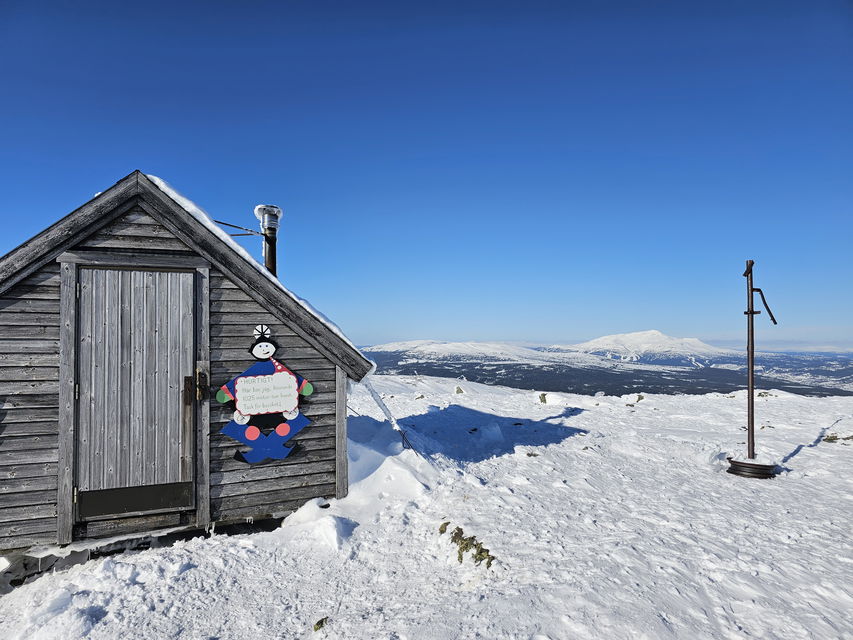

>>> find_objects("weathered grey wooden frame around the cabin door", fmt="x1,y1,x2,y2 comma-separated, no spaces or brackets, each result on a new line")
56,251,210,544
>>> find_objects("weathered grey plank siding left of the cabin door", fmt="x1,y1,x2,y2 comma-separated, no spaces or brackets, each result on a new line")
0,264,60,549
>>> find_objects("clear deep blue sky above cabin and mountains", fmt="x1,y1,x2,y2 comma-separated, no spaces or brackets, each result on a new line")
0,0,853,348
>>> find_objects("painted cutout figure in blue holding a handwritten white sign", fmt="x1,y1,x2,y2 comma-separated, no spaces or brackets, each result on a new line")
216,325,314,464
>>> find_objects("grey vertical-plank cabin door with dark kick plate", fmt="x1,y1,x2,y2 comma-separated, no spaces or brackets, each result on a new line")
75,265,196,520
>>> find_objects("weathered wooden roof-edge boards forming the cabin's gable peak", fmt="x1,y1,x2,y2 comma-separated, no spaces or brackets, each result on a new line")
0,170,373,381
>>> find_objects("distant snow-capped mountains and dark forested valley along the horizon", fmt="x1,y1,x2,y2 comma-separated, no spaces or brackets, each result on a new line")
363,330,853,396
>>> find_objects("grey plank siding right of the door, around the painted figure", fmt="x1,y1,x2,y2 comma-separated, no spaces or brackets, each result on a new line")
210,270,336,520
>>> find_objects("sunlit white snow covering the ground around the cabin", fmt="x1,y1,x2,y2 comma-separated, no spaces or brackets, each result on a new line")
0,376,853,640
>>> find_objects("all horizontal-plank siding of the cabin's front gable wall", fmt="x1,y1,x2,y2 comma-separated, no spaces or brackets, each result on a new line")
0,207,346,550
